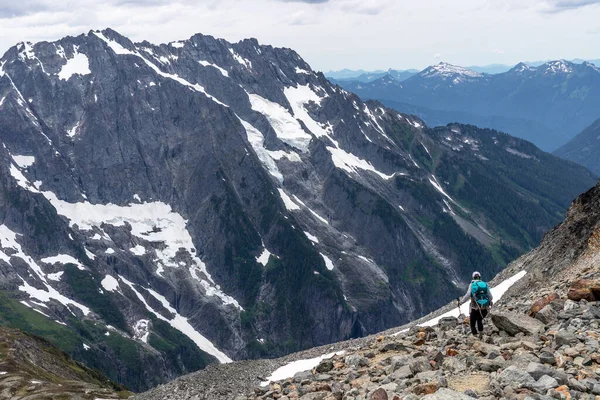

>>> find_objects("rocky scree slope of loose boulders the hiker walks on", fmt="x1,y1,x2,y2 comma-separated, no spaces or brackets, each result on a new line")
140,180,600,400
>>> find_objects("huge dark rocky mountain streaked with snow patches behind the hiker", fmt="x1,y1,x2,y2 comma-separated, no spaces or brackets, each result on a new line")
0,30,596,391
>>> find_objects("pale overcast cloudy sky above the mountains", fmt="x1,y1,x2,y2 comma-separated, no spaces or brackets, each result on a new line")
0,0,600,71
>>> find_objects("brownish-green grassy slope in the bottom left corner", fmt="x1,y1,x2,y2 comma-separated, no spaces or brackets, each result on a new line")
0,327,131,400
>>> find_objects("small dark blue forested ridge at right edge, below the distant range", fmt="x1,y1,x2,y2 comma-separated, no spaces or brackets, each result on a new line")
554,119,600,174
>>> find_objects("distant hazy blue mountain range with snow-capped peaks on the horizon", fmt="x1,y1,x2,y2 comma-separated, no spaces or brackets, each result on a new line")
340,60,600,151
